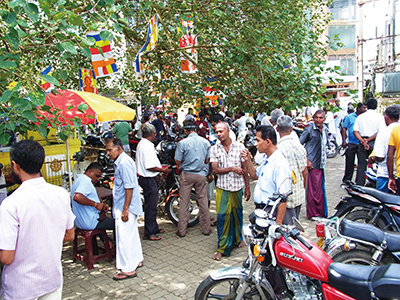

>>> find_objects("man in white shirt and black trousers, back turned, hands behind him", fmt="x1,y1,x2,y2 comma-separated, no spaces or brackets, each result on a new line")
353,98,383,185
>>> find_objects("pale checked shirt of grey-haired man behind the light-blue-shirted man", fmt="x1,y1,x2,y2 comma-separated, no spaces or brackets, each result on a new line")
278,135,307,208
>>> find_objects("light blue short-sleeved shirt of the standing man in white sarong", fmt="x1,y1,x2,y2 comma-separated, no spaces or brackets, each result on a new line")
113,152,143,219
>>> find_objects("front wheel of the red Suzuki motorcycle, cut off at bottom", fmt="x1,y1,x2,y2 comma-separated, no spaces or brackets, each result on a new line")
194,276,274,300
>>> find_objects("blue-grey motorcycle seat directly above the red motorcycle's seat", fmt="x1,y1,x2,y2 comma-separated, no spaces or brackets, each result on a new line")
339,219,400,252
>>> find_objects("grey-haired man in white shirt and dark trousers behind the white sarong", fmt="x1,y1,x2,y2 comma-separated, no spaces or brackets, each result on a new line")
136,124,171,241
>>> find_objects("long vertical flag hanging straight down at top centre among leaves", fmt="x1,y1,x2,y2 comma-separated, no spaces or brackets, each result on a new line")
175,14,197,74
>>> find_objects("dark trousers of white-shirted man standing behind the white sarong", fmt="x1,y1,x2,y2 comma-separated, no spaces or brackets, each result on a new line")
139,176,158,237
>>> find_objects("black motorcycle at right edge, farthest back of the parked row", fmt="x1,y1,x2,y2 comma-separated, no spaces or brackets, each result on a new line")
334,181,400,231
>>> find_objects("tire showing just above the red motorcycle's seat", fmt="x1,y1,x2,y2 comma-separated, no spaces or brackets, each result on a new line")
332,249,395,266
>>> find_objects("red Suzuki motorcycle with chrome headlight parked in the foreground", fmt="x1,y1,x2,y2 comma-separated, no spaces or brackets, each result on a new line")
195,195,400,300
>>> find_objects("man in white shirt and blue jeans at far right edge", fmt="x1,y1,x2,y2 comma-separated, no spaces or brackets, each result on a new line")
368,104,400,193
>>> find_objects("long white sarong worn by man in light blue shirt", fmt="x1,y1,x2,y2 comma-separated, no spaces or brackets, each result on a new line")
115,213,143,273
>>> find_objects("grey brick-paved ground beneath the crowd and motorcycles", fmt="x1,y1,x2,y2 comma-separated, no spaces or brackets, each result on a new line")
62,156,344,300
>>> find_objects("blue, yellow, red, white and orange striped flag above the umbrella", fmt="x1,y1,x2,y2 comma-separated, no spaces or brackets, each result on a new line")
86,31,118,78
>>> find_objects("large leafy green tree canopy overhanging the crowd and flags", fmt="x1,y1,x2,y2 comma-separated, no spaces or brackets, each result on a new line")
0,0,328,145
